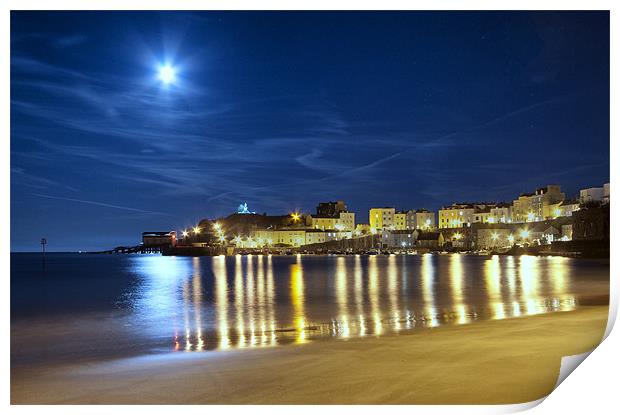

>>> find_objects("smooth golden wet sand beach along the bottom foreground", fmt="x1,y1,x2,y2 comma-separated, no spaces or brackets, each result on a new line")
11,306,608,404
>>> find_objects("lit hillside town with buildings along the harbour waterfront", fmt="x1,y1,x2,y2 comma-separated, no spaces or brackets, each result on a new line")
142,183,609,255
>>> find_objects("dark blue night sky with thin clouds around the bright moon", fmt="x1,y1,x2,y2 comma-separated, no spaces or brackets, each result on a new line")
11,12,609,251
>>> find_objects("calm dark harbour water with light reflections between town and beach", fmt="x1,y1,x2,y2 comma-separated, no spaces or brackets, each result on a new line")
11,254,609,365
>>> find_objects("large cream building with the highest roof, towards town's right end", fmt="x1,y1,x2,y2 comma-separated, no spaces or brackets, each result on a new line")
511,184,566,223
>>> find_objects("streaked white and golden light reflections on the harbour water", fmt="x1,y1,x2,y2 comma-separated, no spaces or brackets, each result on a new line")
129,254,578,351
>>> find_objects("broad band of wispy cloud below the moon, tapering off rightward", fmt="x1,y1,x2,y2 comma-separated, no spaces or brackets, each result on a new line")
11,51,600,221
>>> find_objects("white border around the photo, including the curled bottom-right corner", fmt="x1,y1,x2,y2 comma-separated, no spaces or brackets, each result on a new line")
0,0,620,414
